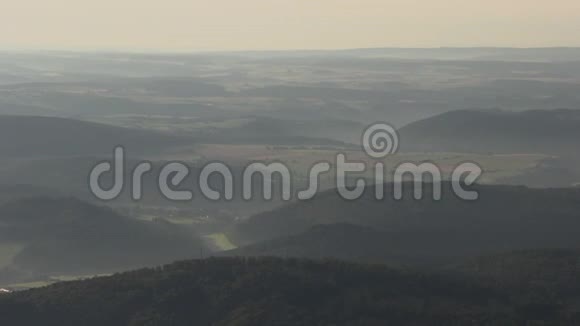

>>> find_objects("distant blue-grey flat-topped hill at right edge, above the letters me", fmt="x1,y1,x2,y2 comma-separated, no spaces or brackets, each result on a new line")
399,109,580,156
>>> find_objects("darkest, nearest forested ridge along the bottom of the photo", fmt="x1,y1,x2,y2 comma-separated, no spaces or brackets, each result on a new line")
0,257,580,326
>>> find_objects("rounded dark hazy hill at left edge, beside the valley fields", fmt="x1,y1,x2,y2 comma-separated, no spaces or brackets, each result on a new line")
0,198,203,283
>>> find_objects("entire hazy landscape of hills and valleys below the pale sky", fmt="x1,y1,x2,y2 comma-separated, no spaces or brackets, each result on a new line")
0,47,580,326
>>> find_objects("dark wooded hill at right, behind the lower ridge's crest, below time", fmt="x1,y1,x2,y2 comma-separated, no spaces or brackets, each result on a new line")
232,182,580,244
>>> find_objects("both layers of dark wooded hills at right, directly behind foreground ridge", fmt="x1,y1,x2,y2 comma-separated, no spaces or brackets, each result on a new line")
230,184,580,264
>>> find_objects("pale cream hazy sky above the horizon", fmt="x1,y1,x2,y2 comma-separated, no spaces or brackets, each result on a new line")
0,0,580,51
